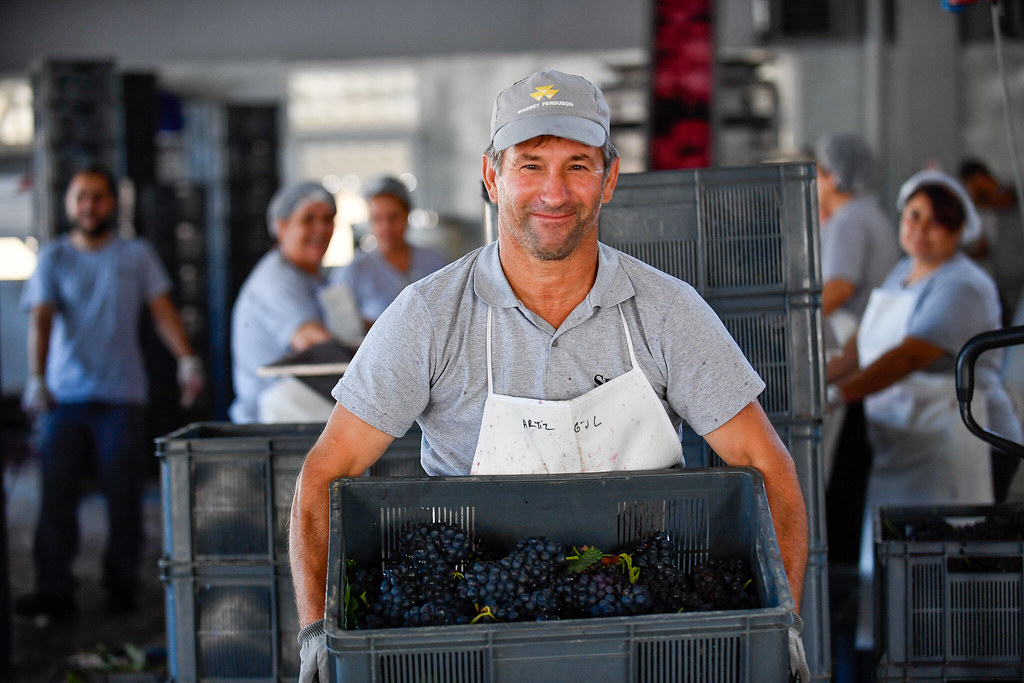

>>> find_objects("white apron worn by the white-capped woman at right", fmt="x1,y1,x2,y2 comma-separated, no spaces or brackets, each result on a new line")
857,289,992,648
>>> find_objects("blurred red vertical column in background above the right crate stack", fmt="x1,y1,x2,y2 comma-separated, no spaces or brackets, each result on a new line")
648,0,715,170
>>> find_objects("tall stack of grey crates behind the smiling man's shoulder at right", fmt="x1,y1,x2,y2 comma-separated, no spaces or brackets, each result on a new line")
599,163,831,680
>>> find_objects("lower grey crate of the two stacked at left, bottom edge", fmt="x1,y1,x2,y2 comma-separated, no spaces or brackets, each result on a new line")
161,562,299,683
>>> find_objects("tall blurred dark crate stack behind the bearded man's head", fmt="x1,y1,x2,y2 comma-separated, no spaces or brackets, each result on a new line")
32,59,123,240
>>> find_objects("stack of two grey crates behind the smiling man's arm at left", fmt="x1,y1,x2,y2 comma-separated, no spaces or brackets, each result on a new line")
157,423,426,683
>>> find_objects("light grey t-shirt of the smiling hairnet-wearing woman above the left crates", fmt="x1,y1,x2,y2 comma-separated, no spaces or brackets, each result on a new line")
228,249,325,423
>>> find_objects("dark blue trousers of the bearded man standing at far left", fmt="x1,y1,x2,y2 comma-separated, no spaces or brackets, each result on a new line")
33,402,145,597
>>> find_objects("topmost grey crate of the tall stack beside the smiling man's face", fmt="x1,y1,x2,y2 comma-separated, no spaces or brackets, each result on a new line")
599,163,821,300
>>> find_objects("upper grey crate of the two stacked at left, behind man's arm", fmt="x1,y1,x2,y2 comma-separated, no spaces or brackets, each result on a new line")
156,423,426,562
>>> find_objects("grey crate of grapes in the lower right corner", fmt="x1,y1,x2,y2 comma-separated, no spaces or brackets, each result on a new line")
874,505,1024,681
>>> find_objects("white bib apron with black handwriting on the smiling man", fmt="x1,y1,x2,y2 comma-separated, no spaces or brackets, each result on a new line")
470,307,683,474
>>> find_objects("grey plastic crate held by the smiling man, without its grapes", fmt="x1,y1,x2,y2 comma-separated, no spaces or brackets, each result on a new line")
327,468,793,683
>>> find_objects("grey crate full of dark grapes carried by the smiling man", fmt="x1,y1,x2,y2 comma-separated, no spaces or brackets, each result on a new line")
327,468,793,683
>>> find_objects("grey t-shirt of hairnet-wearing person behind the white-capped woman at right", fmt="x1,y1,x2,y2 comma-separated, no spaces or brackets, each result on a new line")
821,197,900,319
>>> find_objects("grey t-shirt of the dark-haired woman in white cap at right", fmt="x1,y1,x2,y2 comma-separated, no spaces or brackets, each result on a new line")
882,253,1021,442
